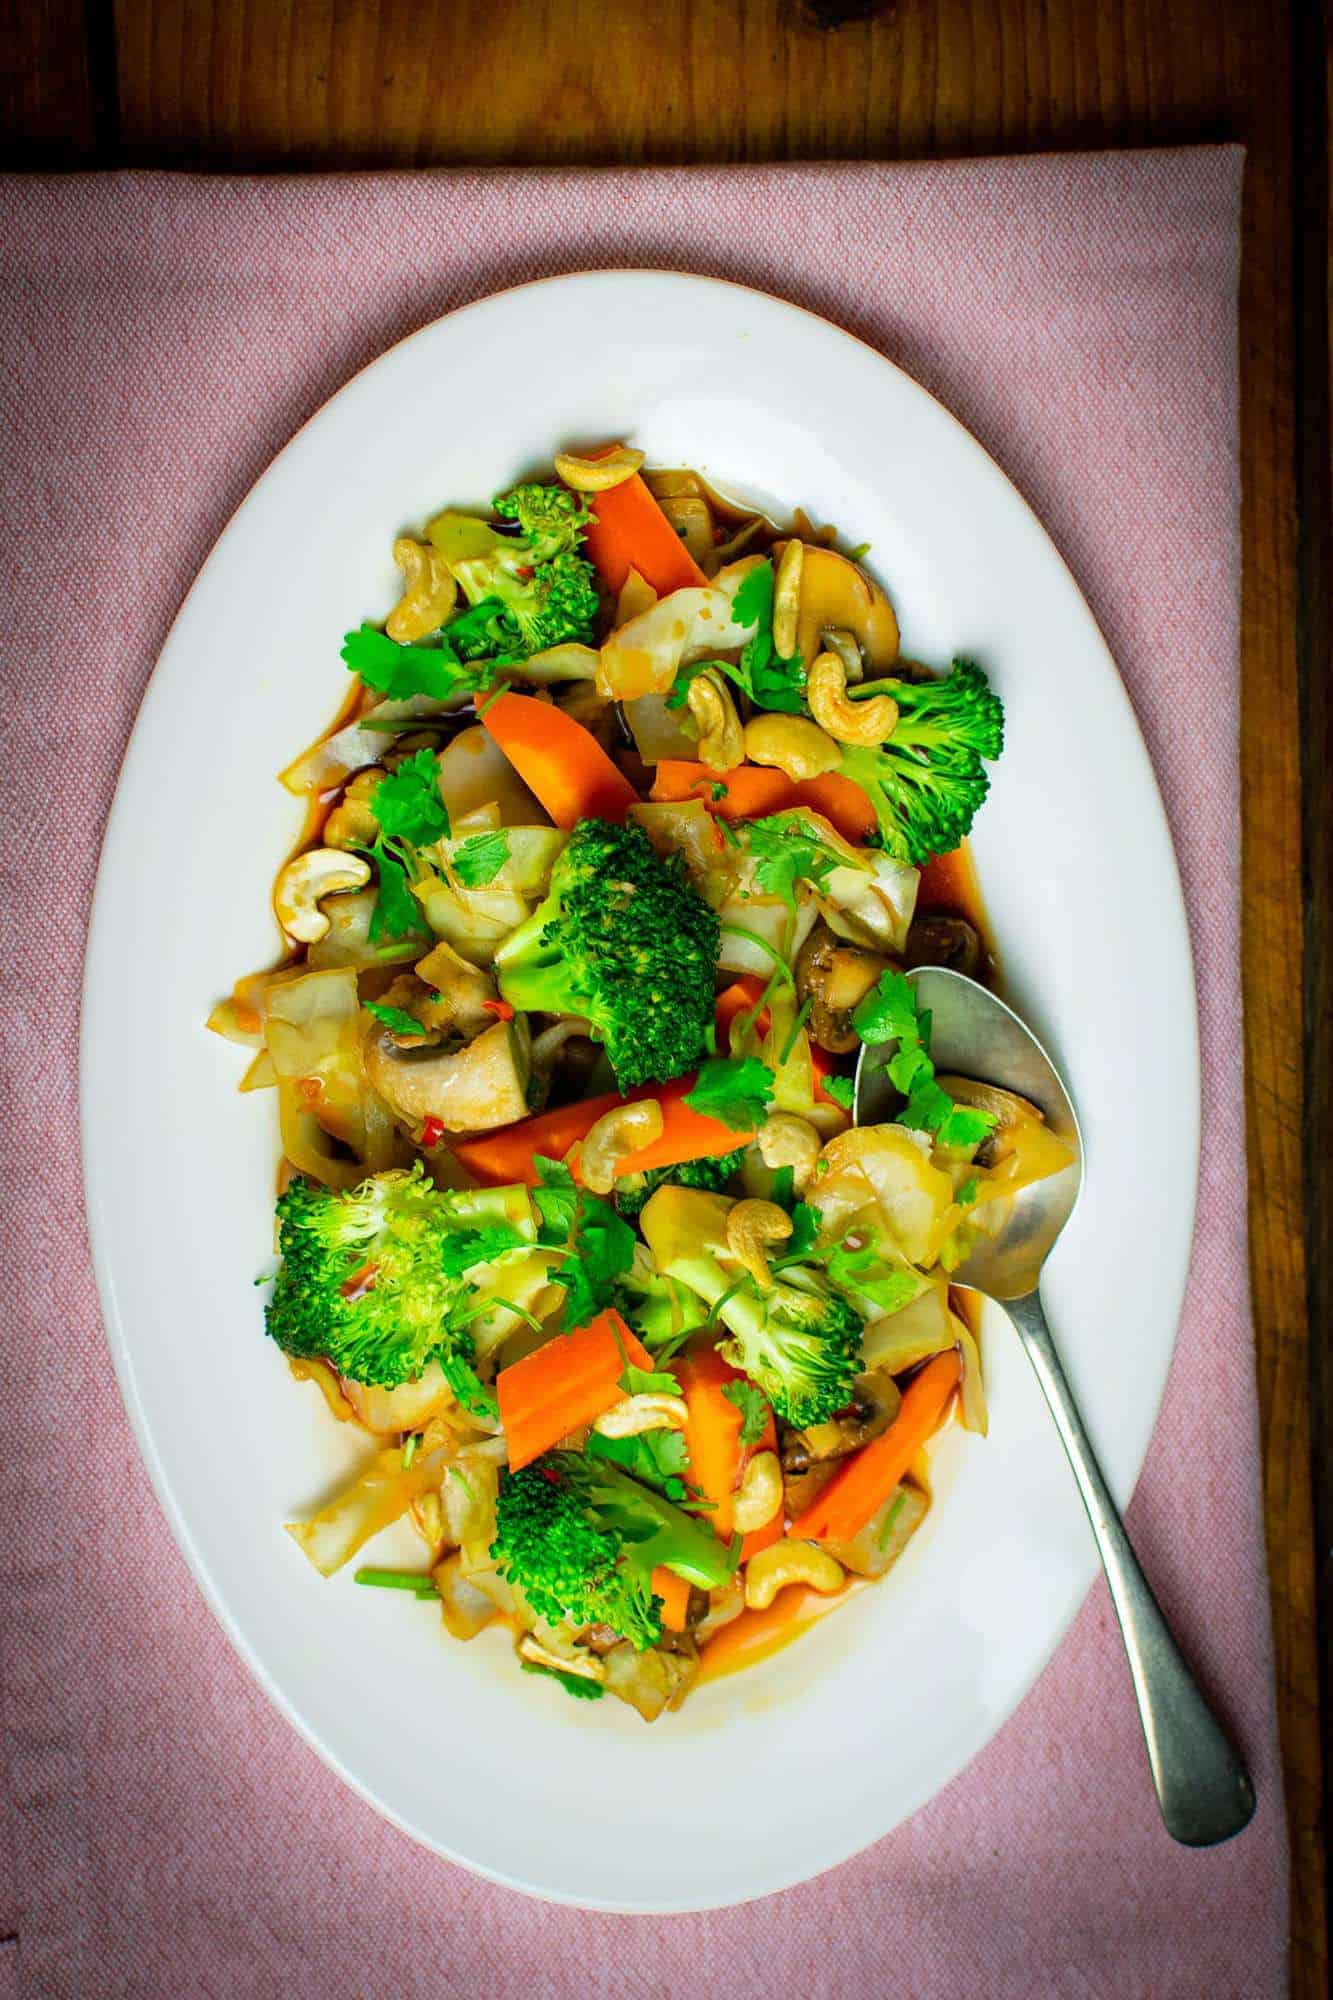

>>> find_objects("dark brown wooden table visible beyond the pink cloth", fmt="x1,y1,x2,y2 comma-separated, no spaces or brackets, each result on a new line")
0,0,1333,1996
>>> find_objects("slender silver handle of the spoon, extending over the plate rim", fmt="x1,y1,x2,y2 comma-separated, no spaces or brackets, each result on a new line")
1007,1292,1255,1848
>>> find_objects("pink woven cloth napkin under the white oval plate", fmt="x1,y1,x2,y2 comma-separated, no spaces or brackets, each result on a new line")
0,148,1287,2000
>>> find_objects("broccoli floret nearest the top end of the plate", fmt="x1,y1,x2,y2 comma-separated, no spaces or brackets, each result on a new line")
430,486,598,660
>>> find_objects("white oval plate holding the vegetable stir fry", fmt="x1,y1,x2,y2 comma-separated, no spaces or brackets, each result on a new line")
82,272,1199,1910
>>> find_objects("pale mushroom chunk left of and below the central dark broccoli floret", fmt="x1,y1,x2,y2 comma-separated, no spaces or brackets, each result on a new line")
366,1016,530,1132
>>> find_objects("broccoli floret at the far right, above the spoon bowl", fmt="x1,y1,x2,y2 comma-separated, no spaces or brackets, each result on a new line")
839,660,1005,866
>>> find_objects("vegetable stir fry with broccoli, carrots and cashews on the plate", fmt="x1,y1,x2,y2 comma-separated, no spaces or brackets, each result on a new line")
210,446,1069,1720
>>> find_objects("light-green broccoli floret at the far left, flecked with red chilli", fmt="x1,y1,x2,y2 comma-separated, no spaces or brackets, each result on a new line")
264,1160,530,1406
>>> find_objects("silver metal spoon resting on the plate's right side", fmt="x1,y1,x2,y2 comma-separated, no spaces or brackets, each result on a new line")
855,966,1255,1848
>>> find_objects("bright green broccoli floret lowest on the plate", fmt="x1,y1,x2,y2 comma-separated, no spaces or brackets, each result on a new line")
490,1452,739,1652
